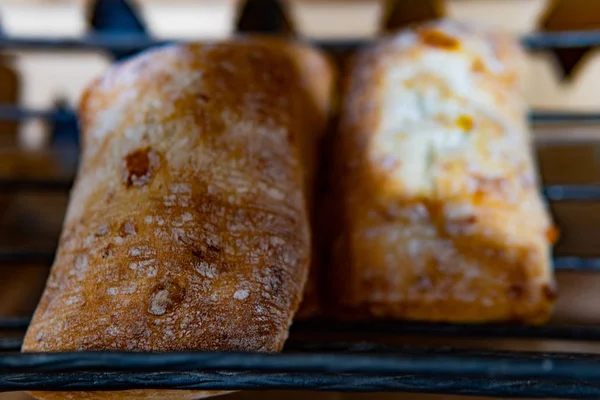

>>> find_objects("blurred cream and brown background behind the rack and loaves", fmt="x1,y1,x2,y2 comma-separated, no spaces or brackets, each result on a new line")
0,0,600,400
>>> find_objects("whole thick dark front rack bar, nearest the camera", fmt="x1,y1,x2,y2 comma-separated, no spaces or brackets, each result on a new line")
0,349,600,398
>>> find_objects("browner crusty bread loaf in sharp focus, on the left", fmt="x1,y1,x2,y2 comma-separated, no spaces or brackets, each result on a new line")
23,38,332,399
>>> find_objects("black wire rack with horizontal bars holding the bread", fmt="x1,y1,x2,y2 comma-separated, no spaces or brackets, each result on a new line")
5,0,600,398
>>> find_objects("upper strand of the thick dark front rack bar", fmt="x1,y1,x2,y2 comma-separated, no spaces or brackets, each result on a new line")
0,345,600,383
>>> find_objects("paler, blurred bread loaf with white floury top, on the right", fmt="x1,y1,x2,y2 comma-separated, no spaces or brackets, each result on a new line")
331,21,556,323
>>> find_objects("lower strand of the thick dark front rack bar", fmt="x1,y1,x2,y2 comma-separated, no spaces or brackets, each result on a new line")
0,372,600,399
